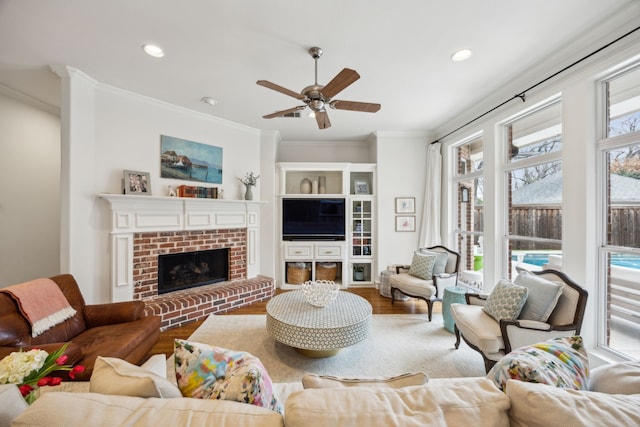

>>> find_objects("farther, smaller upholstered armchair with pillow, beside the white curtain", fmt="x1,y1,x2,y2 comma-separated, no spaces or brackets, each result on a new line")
389,246,460,321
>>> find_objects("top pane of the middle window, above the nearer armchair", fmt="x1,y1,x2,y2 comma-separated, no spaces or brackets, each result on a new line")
507,102,562,162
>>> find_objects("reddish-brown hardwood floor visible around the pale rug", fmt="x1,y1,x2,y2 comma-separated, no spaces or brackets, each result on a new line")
149,288,440,357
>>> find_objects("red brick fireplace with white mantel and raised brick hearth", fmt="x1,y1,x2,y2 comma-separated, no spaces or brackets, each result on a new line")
100,194,275,329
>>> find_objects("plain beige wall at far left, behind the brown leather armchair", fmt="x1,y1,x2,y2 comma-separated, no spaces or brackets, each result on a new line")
0,88,60,287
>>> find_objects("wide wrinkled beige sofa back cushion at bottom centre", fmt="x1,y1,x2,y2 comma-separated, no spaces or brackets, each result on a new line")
285,378,509,427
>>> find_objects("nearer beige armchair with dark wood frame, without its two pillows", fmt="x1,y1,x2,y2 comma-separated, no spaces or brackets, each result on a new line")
451,270,588,372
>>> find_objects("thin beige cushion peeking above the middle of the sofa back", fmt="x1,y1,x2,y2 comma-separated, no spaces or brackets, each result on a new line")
302,372,429,388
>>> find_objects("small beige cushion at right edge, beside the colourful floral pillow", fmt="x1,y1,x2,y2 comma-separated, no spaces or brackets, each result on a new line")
589,361,640,394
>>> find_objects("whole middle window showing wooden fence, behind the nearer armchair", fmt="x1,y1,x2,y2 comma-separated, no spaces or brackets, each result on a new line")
504,98,562,278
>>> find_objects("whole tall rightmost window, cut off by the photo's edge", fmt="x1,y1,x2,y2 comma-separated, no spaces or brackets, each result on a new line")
599,67,640,358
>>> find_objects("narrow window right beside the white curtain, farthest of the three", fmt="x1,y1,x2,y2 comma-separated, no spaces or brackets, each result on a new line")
453,136,484,290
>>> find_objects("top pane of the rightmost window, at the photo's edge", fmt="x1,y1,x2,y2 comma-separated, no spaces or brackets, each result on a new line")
607,69,640,137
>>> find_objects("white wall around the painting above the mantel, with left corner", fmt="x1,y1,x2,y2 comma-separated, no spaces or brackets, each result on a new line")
55,67,262,303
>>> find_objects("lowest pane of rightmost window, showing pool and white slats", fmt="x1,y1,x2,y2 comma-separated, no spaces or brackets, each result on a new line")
606,252,640,358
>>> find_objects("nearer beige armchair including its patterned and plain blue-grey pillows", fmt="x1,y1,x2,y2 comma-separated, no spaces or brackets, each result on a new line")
451,270,588,372
